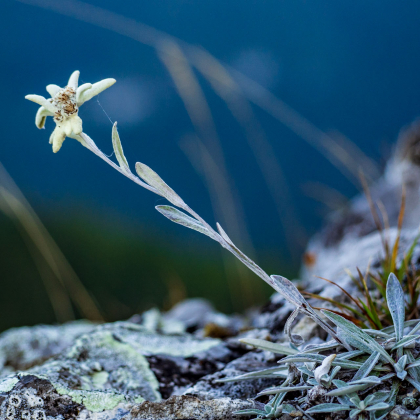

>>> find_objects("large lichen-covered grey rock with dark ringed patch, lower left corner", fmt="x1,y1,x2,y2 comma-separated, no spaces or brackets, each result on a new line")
0,322,226,420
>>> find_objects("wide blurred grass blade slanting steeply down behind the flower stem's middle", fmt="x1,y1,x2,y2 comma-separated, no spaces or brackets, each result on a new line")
158,40,261,309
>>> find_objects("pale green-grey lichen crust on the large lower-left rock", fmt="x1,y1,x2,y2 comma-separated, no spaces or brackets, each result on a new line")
0,322,220,415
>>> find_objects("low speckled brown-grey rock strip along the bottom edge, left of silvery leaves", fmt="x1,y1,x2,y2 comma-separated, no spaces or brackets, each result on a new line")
127,395,254,420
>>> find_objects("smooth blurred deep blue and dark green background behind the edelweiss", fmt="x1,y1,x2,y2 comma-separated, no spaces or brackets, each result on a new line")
0,0,420,328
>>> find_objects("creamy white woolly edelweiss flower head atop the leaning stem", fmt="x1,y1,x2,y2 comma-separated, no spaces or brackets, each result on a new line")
25,70,116,153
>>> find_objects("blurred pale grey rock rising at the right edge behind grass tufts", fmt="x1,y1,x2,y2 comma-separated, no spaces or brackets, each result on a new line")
301,120,420,294
